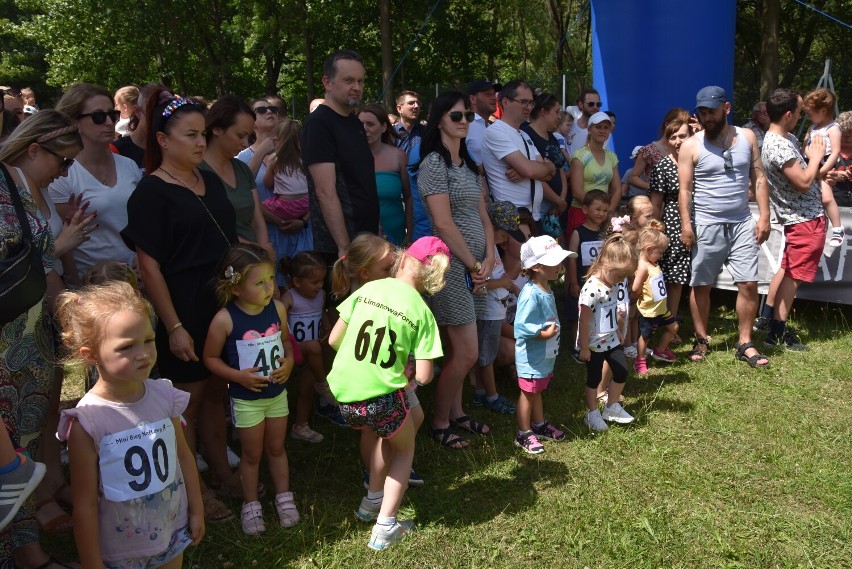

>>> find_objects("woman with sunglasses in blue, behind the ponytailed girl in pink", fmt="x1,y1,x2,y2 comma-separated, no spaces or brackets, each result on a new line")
237,99,314,268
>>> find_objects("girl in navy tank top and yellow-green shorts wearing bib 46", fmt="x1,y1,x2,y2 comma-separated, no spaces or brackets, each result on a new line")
204,243,299,535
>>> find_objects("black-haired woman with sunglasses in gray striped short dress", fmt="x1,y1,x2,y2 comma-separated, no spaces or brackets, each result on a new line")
417,92,494,449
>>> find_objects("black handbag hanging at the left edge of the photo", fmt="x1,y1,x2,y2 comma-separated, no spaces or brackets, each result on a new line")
0,164,47,324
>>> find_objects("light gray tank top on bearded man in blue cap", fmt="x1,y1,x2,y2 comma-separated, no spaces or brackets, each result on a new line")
693,127,751,225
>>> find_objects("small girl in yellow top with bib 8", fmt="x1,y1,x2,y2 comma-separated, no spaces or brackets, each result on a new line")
632,219,678,375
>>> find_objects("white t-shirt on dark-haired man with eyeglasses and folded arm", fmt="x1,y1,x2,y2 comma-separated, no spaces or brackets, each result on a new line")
482,120,543,220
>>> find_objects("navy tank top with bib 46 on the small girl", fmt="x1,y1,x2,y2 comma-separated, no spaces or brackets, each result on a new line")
225,301,285,400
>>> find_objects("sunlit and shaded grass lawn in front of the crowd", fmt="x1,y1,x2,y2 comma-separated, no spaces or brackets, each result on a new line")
46,291,852,569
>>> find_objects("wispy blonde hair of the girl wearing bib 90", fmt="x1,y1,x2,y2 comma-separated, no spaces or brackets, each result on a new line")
56,281,155,364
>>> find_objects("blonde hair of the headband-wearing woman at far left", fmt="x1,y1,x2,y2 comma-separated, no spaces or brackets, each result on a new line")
0,109,83,164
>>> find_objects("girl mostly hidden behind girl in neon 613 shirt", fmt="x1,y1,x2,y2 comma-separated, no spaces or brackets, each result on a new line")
331,233,425,488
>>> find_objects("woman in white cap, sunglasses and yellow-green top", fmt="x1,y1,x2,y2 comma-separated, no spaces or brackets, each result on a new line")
565,111,621,239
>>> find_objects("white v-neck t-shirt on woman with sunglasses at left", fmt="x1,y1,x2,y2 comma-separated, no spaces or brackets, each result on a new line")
47,154,142,276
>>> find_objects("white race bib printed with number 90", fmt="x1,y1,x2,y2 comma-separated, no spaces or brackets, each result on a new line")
98,419,178,502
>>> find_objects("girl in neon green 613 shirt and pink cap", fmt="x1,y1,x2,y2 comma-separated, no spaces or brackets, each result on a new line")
328,237,450,549
